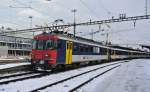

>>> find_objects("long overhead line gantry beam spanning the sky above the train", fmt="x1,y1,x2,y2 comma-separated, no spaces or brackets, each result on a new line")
0,15,150,34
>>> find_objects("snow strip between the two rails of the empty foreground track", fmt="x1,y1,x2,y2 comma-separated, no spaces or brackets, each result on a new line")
41,64,119,92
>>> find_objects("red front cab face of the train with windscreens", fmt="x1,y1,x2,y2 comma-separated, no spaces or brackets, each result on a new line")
31,36,57,69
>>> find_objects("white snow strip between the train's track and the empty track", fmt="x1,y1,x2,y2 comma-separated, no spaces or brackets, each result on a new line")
0,62,122,92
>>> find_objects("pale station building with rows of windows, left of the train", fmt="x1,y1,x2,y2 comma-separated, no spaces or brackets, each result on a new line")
0,35,32,57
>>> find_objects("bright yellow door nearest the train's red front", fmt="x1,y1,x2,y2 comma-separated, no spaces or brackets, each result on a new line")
66,41,73,64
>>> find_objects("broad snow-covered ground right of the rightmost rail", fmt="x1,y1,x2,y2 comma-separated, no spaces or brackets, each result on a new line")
78,59,150,92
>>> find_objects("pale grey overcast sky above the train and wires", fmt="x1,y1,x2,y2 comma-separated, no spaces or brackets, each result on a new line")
0,0,150,44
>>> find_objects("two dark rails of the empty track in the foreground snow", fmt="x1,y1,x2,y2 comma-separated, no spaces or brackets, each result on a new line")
30,62,125,92
